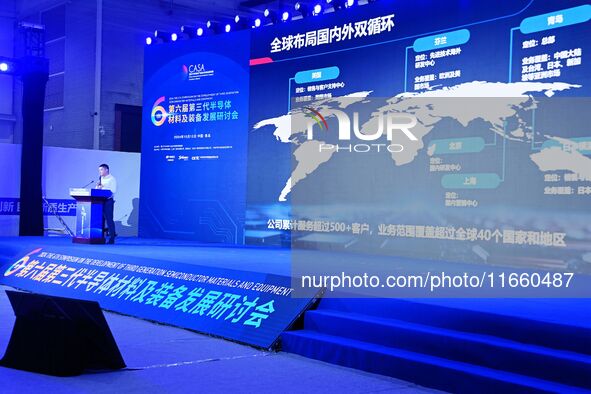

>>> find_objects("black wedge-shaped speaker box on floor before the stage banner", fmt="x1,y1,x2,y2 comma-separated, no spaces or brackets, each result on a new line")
0,290,125,376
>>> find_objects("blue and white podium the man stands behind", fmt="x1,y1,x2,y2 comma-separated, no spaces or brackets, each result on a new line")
70,188,112,244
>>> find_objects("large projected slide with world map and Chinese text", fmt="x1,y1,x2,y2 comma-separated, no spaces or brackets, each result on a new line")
245,0,591,270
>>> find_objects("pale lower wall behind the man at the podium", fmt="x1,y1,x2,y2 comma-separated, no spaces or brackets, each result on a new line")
0,144,140,236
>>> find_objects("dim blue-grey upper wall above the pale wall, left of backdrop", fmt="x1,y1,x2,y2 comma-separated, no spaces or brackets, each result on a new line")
11,0,222,150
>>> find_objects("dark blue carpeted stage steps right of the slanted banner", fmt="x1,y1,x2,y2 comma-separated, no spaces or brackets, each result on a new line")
282,299,591,393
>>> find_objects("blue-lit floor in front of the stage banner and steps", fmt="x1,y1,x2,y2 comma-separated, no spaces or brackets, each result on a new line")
0,286,436,394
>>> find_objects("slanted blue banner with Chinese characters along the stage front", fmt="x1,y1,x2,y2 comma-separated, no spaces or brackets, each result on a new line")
0,247,317,349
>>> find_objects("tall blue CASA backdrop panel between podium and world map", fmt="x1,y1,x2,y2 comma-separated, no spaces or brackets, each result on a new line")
139,31,250,244
